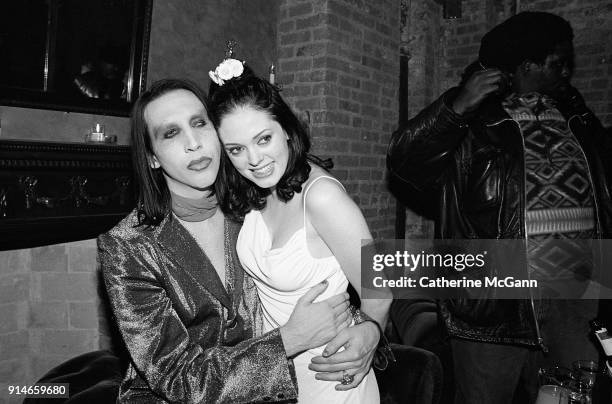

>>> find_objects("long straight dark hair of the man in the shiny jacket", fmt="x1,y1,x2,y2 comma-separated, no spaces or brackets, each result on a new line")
130,79,207,226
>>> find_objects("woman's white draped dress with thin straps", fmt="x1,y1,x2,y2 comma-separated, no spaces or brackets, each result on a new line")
236,176,380,404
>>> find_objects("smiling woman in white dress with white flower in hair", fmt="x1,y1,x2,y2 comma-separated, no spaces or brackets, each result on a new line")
209,58,390,404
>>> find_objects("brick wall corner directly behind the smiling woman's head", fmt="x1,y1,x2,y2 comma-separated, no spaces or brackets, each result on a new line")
277,0,400,237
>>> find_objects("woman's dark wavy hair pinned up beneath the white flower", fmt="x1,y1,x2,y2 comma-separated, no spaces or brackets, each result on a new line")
208,65,333,219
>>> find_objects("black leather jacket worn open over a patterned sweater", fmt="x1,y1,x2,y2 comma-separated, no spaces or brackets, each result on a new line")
387,88,612,345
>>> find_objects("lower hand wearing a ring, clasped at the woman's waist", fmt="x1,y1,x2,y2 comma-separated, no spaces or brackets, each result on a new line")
308,321,380,390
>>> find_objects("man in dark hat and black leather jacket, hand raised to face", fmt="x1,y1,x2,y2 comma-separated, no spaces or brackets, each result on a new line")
387,12,612,404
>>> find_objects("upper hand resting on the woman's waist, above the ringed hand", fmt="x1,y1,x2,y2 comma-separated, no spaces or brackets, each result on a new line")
280,281,352,357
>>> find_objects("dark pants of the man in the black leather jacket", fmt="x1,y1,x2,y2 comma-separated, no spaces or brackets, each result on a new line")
451,338,541,404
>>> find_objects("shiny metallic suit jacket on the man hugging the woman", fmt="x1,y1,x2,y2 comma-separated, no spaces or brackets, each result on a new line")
98,212,297,403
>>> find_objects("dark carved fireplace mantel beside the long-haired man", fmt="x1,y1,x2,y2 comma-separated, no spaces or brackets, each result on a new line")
0,140,134,250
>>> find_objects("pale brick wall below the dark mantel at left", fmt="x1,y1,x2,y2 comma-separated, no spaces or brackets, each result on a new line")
0,240,99,403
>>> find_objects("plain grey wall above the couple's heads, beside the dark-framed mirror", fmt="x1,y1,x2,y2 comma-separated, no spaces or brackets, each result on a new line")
147,0,280,85
